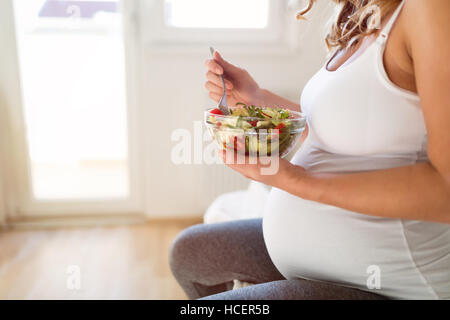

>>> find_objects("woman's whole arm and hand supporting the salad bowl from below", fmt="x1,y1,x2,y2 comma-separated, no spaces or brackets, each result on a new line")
224,0,450,224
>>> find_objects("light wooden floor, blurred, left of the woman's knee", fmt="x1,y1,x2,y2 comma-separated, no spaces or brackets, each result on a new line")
0,221,201,299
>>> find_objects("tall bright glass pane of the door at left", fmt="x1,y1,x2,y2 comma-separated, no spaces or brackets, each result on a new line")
14,0,129,200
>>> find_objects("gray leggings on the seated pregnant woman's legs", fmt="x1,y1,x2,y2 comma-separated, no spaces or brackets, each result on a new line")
170,219,384,300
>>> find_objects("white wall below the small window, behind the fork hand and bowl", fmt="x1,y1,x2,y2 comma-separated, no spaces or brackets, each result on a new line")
141,1,330,216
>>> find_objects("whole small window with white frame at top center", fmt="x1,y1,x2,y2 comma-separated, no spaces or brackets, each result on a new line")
141,0,287,46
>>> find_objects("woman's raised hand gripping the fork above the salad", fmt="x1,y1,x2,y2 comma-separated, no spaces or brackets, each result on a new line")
205,51,262,107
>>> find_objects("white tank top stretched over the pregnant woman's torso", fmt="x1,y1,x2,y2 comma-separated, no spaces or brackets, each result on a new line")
263,3,450,299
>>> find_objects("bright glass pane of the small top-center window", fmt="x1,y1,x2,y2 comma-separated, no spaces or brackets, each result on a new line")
165,0,269,29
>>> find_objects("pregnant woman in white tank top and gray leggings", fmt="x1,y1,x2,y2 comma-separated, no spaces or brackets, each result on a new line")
170,0,450,299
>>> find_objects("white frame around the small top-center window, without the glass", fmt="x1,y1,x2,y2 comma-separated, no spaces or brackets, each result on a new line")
140,0,289,48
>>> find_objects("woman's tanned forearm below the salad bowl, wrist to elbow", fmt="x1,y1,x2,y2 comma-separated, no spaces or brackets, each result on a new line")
284,163,450,224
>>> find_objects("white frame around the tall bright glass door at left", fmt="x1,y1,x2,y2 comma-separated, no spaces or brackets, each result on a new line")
0,0,144,219
